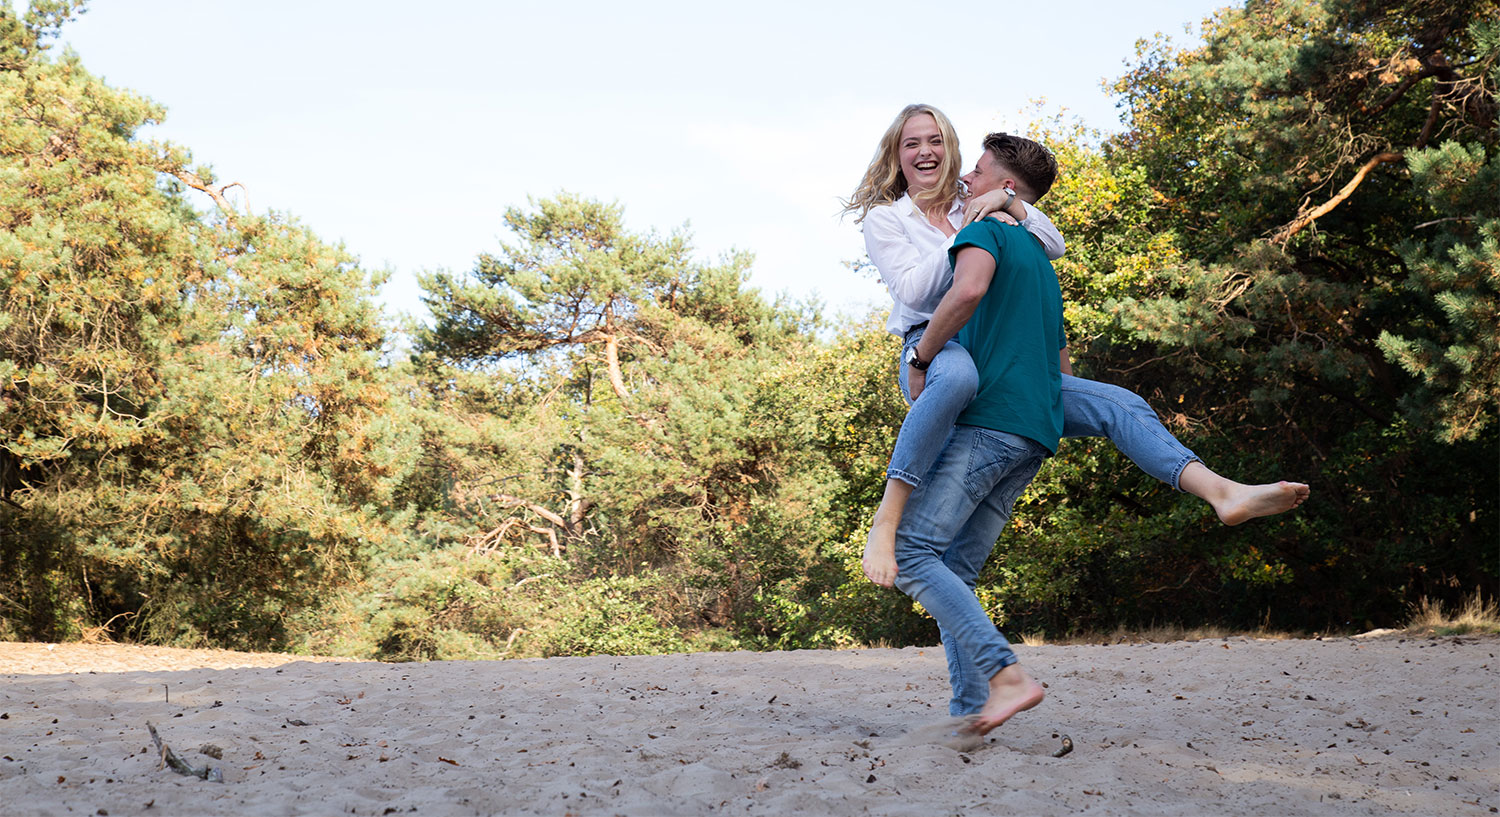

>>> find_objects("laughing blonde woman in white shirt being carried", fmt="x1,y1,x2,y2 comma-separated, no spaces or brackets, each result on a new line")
845,105,1308,588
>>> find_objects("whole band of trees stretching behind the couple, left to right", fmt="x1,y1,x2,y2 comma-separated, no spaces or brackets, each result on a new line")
0,0,1500,658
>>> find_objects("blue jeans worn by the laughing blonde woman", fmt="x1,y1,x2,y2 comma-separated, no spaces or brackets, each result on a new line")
885,330,1199,490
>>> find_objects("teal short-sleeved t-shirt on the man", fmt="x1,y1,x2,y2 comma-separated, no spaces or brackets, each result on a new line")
948,219,1068,454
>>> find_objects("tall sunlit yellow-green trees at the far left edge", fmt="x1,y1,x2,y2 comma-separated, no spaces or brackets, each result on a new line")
0,4,414,646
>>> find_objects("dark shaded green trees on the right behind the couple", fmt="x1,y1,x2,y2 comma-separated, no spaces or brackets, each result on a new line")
1020,0,1500,630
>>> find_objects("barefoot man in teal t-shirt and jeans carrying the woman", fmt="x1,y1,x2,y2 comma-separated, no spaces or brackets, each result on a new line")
896,133,1070,735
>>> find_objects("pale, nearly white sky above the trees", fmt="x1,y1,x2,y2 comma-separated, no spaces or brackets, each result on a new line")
35,0,1227,325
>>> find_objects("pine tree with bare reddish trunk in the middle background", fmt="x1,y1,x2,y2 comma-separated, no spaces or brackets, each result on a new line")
417,195,840,652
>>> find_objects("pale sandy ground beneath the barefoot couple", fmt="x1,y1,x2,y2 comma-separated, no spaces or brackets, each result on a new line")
0,634,1500,817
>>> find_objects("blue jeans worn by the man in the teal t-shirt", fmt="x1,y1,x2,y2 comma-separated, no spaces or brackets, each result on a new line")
896,426,1050,715
